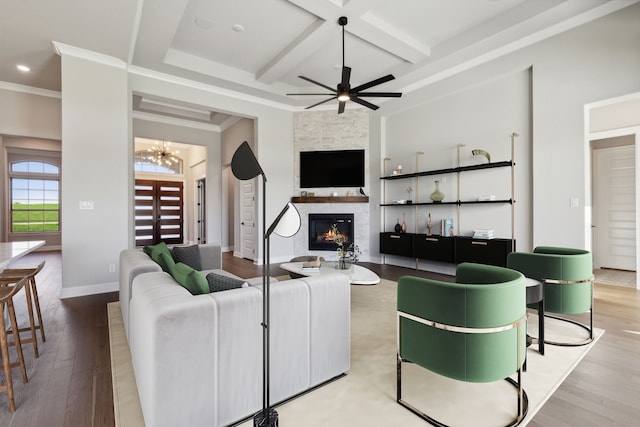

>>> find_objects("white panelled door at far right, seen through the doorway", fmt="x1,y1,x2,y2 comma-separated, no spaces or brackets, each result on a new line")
593,145,636,271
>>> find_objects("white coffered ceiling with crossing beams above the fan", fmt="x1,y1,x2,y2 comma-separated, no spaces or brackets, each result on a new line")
0,0,639,122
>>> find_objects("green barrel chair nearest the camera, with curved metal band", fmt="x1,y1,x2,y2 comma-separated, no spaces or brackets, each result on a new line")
397,263,528,426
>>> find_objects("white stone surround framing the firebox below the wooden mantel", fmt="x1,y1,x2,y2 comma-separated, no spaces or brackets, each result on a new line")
294,203,369,261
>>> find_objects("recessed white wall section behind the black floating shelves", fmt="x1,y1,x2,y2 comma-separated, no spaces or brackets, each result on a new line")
381,70,531,266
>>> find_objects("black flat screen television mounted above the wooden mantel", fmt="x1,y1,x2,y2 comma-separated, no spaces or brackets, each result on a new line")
300,150,364,188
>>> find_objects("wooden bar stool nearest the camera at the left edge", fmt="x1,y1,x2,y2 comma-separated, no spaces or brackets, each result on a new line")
0,277,28,412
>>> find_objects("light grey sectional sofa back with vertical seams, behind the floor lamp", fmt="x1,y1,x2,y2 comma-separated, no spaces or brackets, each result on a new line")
121,250,350,427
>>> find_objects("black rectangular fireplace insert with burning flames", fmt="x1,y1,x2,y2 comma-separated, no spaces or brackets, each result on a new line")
309,213,354,251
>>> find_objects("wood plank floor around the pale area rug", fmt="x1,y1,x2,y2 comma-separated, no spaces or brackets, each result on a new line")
0,252,640,427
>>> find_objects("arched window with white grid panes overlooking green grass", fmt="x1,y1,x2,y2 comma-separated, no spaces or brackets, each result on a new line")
9,160,60,233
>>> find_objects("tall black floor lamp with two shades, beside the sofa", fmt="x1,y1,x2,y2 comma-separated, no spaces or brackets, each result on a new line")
231,141,300,427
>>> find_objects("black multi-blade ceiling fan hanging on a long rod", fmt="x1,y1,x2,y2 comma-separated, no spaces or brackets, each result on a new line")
287,16,402,114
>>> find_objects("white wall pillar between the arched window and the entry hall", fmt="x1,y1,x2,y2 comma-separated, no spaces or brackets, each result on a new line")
61,55,132,297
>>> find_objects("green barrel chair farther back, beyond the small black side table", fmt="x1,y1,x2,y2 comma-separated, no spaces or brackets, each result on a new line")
507,246,593,346
